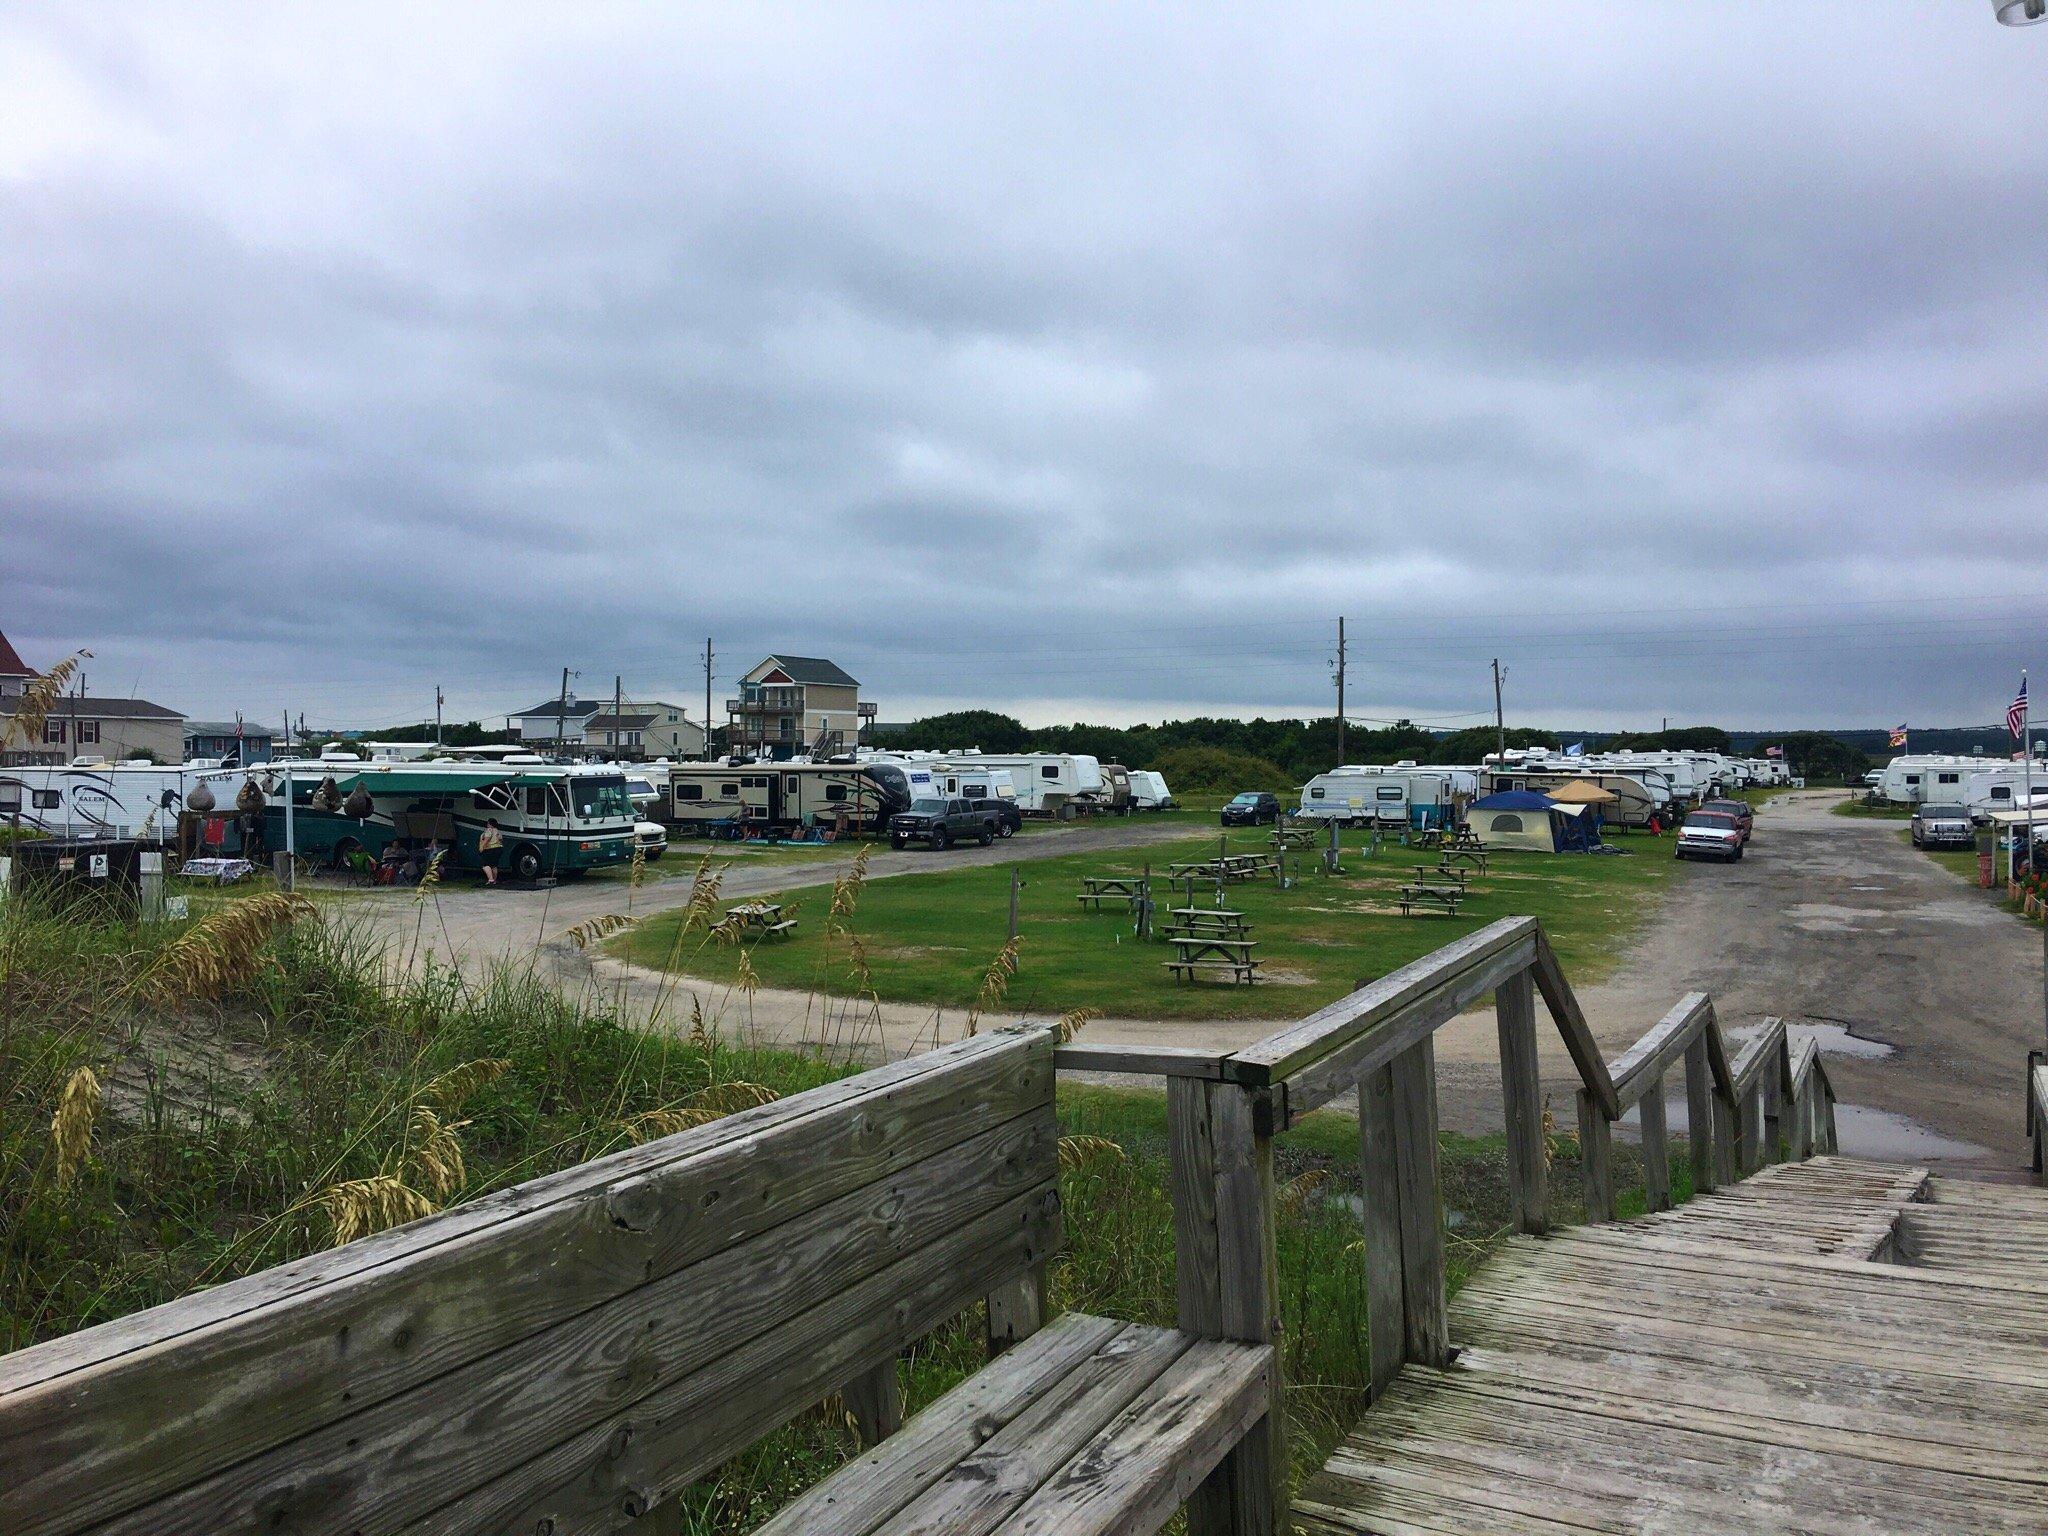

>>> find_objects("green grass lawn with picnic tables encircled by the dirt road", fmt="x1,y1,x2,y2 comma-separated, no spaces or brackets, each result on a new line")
612,829,1677,1018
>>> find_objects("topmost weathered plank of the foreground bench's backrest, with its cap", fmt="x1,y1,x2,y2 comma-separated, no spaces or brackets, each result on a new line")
0,1030,1053,1536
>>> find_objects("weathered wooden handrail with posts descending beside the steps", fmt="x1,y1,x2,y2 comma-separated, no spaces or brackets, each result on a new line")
1057,918,1843,1532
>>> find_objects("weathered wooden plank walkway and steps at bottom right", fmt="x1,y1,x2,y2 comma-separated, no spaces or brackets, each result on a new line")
1294,1157,2048,1536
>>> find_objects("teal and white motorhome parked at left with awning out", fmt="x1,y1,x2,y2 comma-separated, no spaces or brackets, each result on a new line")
213,758,639,881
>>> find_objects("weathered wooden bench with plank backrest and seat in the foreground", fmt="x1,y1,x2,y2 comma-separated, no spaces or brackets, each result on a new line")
0,1028,1286,1536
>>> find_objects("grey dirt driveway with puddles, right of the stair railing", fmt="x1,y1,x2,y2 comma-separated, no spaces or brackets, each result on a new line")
1438,791,2044,1165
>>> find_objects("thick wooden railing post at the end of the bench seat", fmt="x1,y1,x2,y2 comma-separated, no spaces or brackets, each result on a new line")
1167,1077,1288,1536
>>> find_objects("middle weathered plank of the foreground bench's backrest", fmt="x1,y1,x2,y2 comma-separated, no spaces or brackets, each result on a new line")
96,1110,1059,1536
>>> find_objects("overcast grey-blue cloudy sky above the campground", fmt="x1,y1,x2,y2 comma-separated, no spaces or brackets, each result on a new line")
0,0,2048,741
